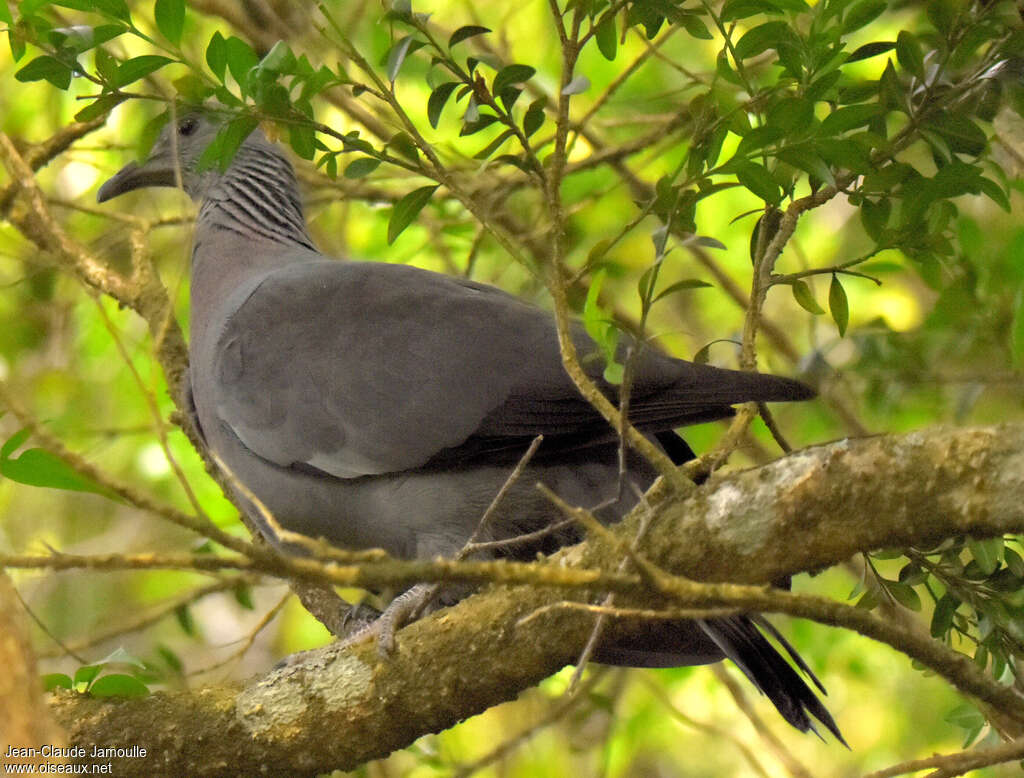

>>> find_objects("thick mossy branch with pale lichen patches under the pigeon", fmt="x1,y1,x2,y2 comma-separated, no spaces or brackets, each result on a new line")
46,425,1024,775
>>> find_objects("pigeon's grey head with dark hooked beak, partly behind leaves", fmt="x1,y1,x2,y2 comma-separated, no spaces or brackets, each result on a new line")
96,111,230,203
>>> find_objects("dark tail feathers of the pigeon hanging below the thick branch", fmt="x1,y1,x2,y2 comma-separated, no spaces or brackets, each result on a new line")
699,616,850,748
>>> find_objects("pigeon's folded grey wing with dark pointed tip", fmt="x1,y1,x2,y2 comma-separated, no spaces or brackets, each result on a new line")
215,261,806,477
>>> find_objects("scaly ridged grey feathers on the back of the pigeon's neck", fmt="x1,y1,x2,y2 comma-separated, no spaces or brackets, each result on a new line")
197,139,316,251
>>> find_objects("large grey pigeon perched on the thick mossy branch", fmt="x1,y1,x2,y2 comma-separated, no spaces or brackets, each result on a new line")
98,113,843,741
